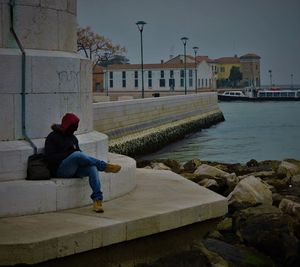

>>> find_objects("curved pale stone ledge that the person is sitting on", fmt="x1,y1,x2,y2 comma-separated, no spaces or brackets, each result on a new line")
0,153,136,217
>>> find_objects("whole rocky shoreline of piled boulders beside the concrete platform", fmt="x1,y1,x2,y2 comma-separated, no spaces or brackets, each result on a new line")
137,159,300,267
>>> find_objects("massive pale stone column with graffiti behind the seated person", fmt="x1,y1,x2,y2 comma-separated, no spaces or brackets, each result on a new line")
0,0,107,181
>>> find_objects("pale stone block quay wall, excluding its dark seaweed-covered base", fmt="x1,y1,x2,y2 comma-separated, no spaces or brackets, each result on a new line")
93,93,218,137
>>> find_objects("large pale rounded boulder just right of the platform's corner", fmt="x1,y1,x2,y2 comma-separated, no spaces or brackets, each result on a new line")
227,176,272,213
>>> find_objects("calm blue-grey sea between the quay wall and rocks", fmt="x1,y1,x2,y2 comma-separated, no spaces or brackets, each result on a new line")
138,102,300,163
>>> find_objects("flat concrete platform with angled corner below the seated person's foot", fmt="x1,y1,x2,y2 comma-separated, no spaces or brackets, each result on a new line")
0,169,227,265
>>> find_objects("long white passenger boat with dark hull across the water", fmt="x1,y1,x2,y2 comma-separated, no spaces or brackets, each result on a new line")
218,87,300,101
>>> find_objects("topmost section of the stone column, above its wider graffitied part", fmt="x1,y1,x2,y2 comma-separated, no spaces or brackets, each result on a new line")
0,0,76,52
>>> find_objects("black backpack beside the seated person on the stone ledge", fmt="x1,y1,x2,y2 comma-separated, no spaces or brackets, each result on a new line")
26,153,51,180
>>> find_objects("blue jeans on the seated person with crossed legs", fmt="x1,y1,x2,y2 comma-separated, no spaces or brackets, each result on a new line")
57,151,107,200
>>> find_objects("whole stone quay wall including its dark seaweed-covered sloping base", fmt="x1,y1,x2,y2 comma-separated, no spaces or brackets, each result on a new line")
93,92,224,156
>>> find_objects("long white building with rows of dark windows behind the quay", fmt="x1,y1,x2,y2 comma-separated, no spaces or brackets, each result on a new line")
104,58,213,91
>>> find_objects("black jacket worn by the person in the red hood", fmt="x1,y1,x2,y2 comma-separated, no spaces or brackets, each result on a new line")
45,124,80,177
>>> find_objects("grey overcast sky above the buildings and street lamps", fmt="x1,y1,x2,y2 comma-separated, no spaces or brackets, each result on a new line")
77,0,300,84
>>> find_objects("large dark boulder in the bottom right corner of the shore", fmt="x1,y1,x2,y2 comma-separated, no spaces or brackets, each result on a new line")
233,205,299,266
